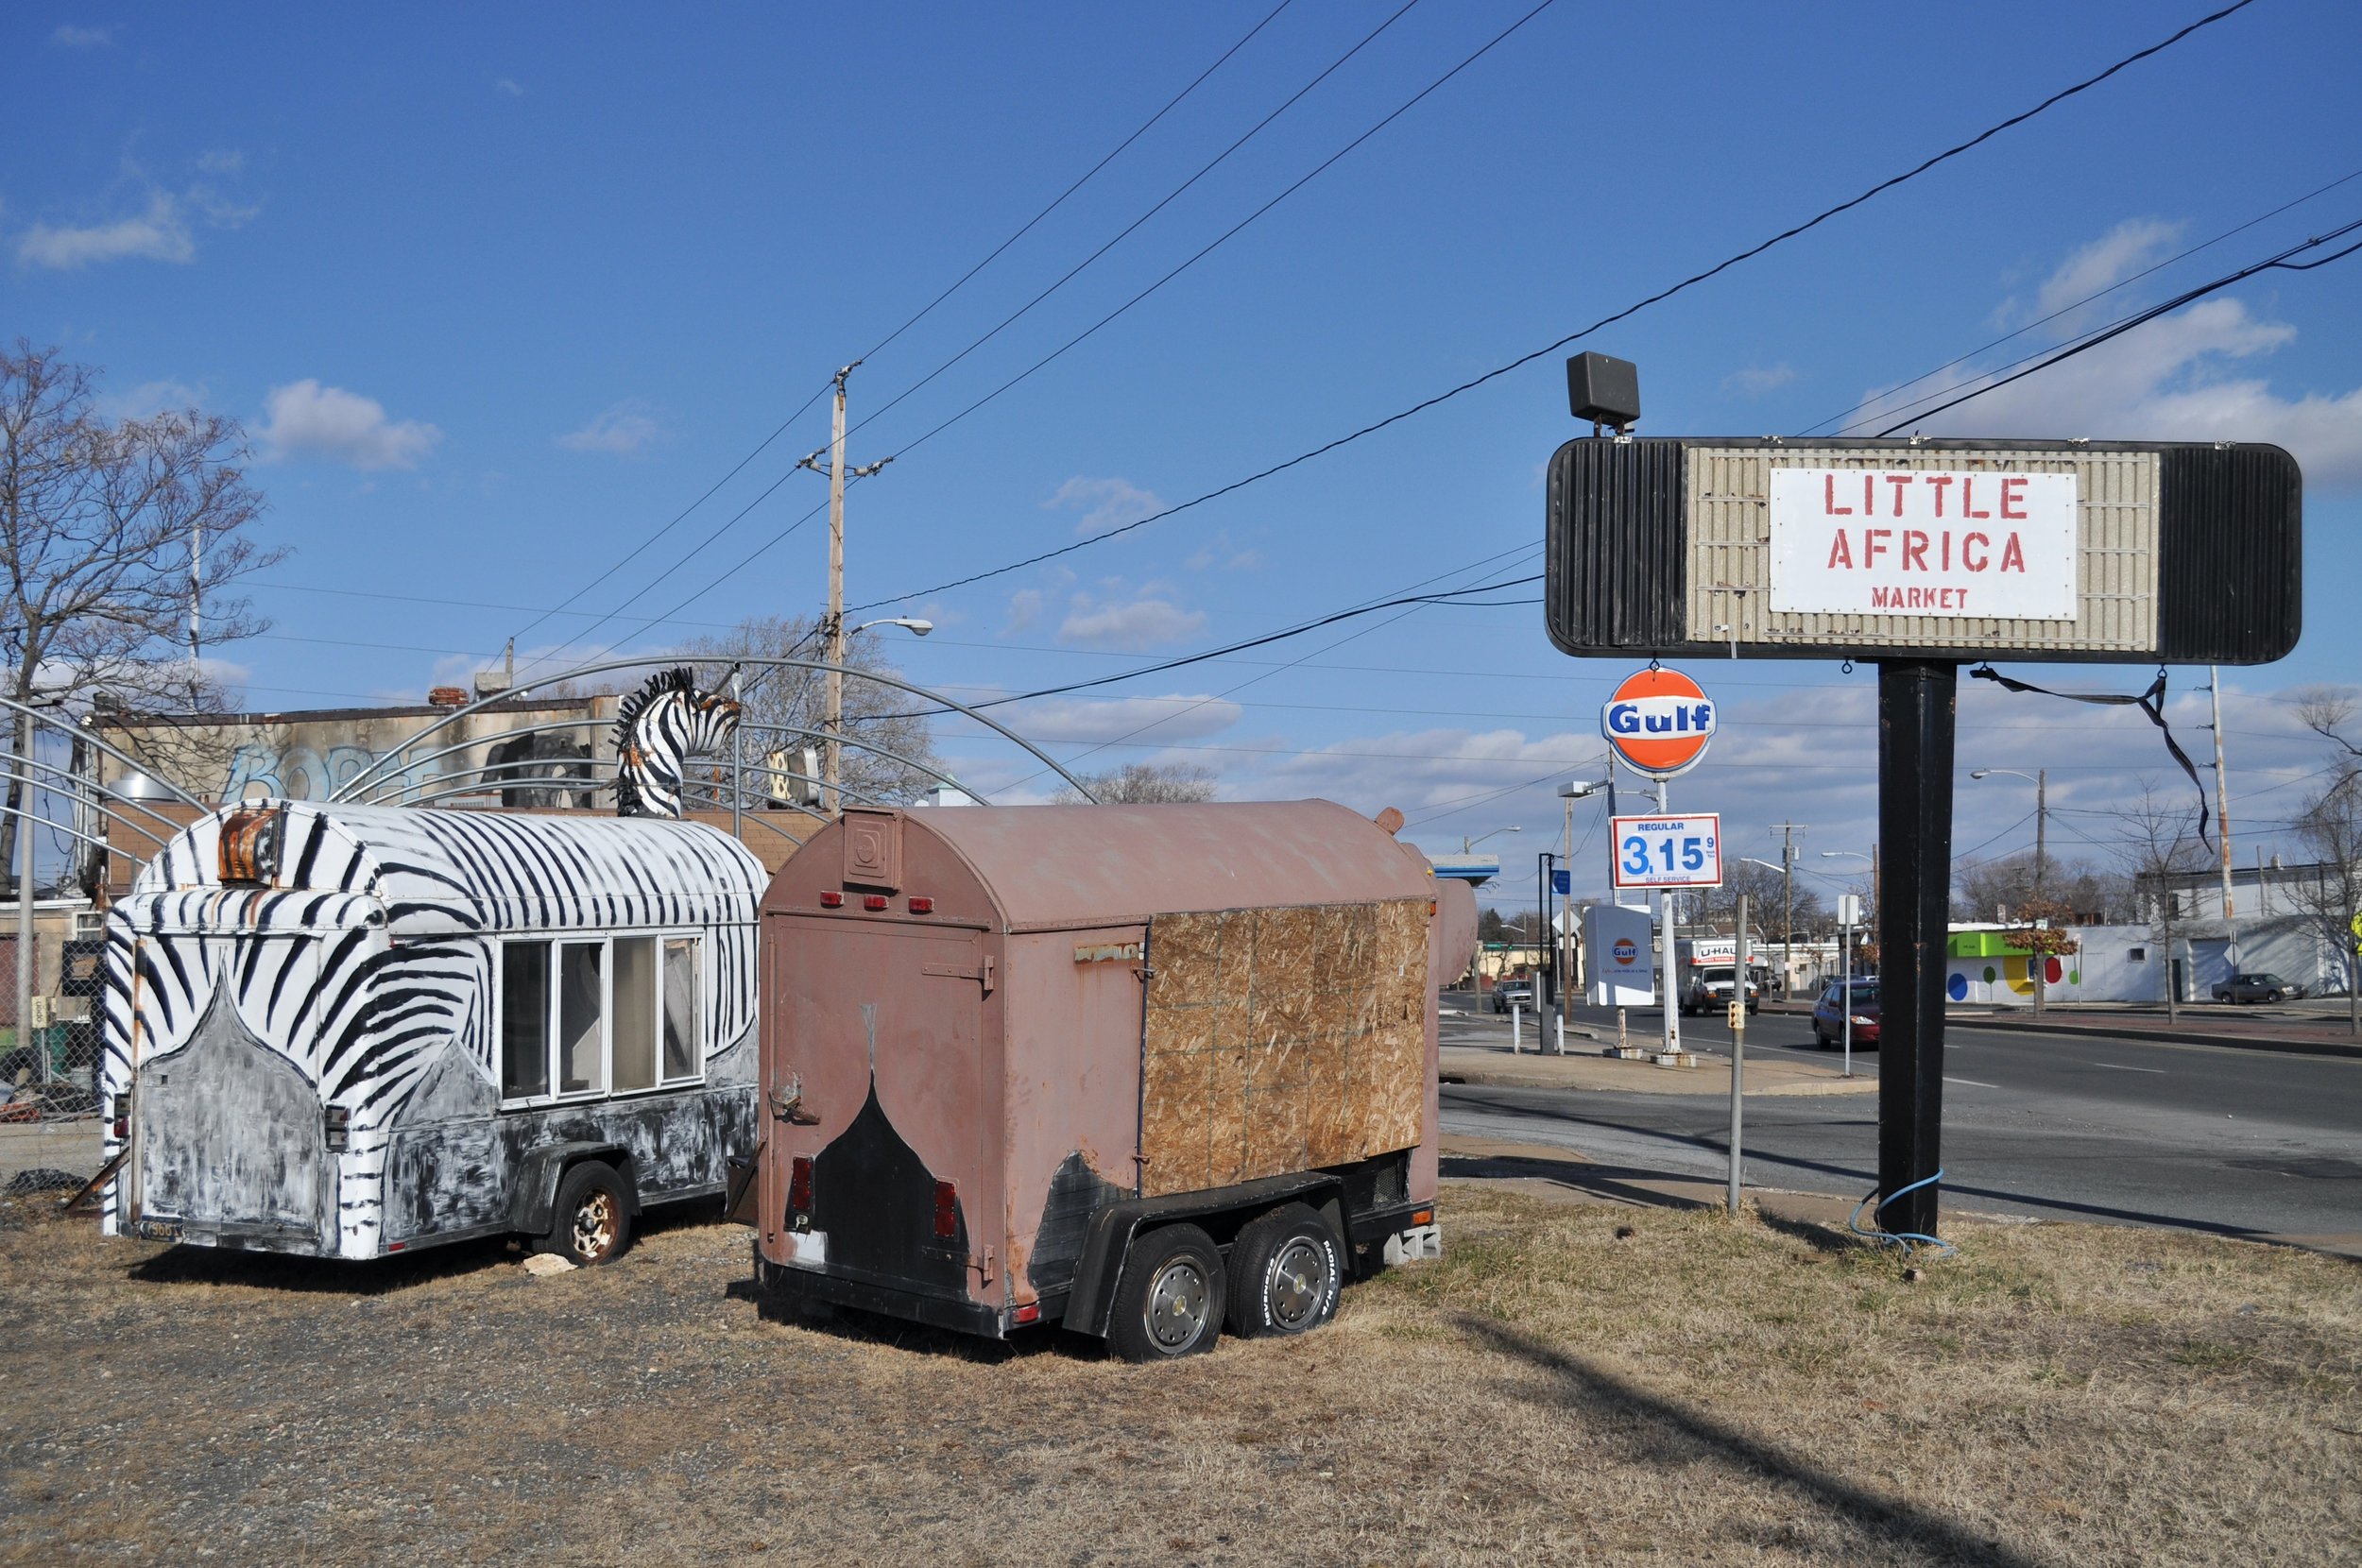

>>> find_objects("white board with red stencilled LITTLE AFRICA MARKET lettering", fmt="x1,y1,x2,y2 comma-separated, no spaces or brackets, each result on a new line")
1770,468,2079,622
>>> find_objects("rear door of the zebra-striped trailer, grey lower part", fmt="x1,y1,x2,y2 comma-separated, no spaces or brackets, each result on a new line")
130,933,335,1247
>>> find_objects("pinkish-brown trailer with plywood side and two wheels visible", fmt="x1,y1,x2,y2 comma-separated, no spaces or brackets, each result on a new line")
740,801,1472,1360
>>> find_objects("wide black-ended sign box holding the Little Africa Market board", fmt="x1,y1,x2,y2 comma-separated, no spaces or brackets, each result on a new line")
1543,437,2303,664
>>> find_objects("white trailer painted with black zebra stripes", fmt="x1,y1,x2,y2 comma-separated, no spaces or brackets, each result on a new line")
104,801,765,1264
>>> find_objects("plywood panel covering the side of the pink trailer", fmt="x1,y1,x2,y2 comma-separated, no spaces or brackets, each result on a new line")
1141,900,1427,1195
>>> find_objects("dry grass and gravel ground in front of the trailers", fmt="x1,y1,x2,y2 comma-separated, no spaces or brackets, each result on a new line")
0,1185,2362,1566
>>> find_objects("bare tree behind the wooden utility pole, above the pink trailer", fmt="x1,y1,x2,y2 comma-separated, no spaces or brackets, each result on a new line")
680,617,943,810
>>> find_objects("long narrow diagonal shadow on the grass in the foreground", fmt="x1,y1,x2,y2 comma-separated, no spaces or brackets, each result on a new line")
1458,1313,2041,1568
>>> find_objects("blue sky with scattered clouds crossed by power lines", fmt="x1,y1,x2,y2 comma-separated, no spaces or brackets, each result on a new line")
0,0,2362,900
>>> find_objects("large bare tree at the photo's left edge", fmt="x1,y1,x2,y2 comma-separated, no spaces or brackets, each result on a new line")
0,338,283,893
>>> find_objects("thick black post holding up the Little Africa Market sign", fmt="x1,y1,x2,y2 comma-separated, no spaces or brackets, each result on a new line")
1847,659,1960,1236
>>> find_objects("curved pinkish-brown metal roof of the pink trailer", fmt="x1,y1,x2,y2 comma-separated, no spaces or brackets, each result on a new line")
902,801,1434,930
